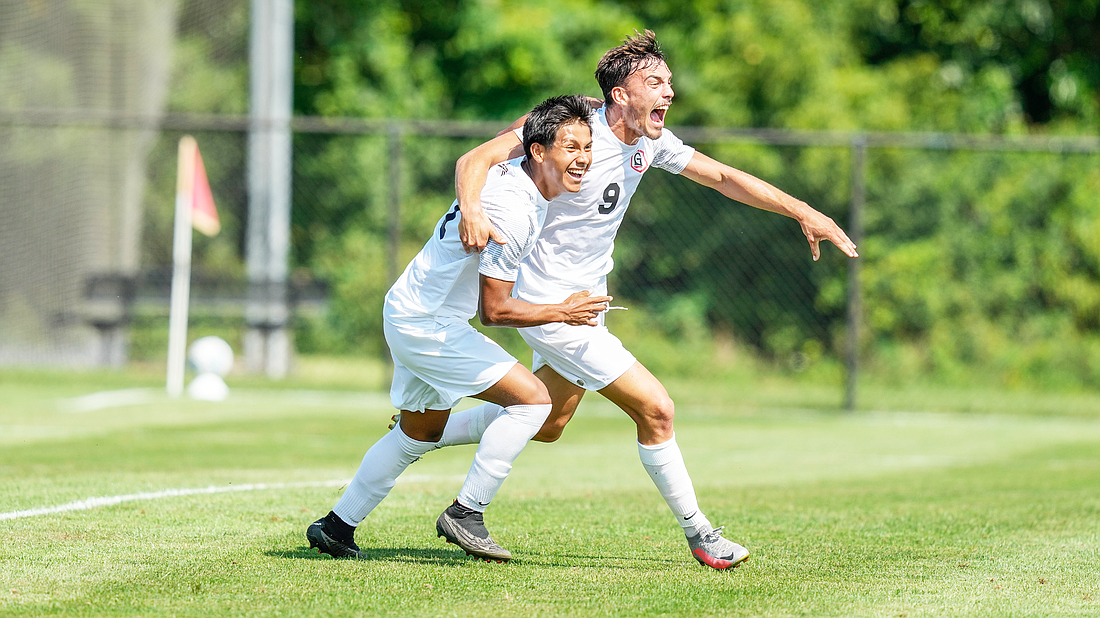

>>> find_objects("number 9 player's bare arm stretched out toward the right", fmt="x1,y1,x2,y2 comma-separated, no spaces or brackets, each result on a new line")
681,152,859,262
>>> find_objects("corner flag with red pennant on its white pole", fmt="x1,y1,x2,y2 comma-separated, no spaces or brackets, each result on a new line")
167,135,221,397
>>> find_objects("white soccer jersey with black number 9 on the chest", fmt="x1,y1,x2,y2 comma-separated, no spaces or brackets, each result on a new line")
510,106,695,302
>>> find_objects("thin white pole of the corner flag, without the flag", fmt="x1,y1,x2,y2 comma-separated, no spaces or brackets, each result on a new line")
168,135,198,397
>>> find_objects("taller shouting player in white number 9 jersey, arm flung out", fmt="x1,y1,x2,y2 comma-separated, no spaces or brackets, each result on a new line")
429,30,857,569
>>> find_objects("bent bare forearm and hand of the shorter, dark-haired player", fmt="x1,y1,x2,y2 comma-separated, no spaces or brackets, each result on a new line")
477,275,612,328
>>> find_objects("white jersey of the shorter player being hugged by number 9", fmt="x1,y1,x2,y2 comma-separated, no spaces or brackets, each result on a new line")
384,157,547,321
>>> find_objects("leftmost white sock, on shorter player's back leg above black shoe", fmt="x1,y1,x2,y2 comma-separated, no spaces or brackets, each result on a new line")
332,424,436,526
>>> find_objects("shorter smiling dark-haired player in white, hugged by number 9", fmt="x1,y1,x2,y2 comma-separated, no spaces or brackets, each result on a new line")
306,96,611,562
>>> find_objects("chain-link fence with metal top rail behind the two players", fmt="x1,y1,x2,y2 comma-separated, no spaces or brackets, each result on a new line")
2,108,1097,393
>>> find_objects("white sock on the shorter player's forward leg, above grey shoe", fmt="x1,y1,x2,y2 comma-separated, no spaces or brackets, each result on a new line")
459,404,551,512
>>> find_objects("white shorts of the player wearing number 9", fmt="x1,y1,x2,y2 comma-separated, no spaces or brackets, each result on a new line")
519,313,636,390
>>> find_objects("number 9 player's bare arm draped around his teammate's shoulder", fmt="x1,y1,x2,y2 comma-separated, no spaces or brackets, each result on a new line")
454,131,524,253
